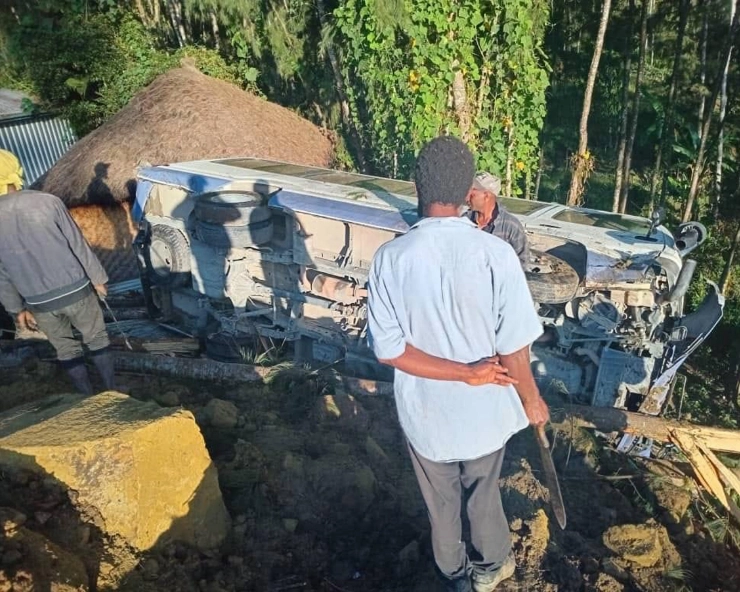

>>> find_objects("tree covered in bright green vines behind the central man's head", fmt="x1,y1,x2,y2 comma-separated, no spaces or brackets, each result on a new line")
334,0,548,194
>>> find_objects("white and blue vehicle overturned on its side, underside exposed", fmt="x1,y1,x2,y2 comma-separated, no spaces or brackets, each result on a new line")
134,158,724,415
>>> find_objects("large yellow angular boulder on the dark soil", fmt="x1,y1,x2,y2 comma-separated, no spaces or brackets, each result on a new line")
0,392,230,551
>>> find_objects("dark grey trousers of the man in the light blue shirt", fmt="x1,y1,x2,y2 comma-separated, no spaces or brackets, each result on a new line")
409,444,511,580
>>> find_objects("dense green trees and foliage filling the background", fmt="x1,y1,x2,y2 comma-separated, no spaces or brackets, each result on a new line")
0,0,740,423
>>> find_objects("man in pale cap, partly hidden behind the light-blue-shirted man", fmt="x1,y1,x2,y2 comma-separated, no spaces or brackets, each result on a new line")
467,172,529,267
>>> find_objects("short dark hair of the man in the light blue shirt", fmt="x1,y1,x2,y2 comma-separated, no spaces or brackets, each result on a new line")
414,136,475,212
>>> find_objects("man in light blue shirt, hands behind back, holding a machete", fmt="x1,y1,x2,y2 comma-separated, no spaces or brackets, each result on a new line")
368,136,549,592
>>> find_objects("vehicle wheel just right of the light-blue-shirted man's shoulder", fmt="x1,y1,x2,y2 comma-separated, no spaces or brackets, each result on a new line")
524,251,580,304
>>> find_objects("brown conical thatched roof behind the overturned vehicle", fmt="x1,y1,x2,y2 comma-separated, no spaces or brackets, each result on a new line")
35,66,333,207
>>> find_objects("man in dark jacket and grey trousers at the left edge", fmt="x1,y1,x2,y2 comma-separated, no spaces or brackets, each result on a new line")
0,155,115,395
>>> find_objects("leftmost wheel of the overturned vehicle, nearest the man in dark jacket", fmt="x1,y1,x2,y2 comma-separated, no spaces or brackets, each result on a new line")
145,224,190,288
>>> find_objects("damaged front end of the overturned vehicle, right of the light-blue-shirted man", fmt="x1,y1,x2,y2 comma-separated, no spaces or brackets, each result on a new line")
516,200,724,415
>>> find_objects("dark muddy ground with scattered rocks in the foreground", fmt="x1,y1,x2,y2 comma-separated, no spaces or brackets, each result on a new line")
0,362,740,592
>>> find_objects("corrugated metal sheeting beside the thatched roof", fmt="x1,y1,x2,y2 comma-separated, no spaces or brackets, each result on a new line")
0,115,77,187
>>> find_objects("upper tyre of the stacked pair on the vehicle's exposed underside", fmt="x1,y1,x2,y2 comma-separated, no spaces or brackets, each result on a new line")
194,191,272,226
